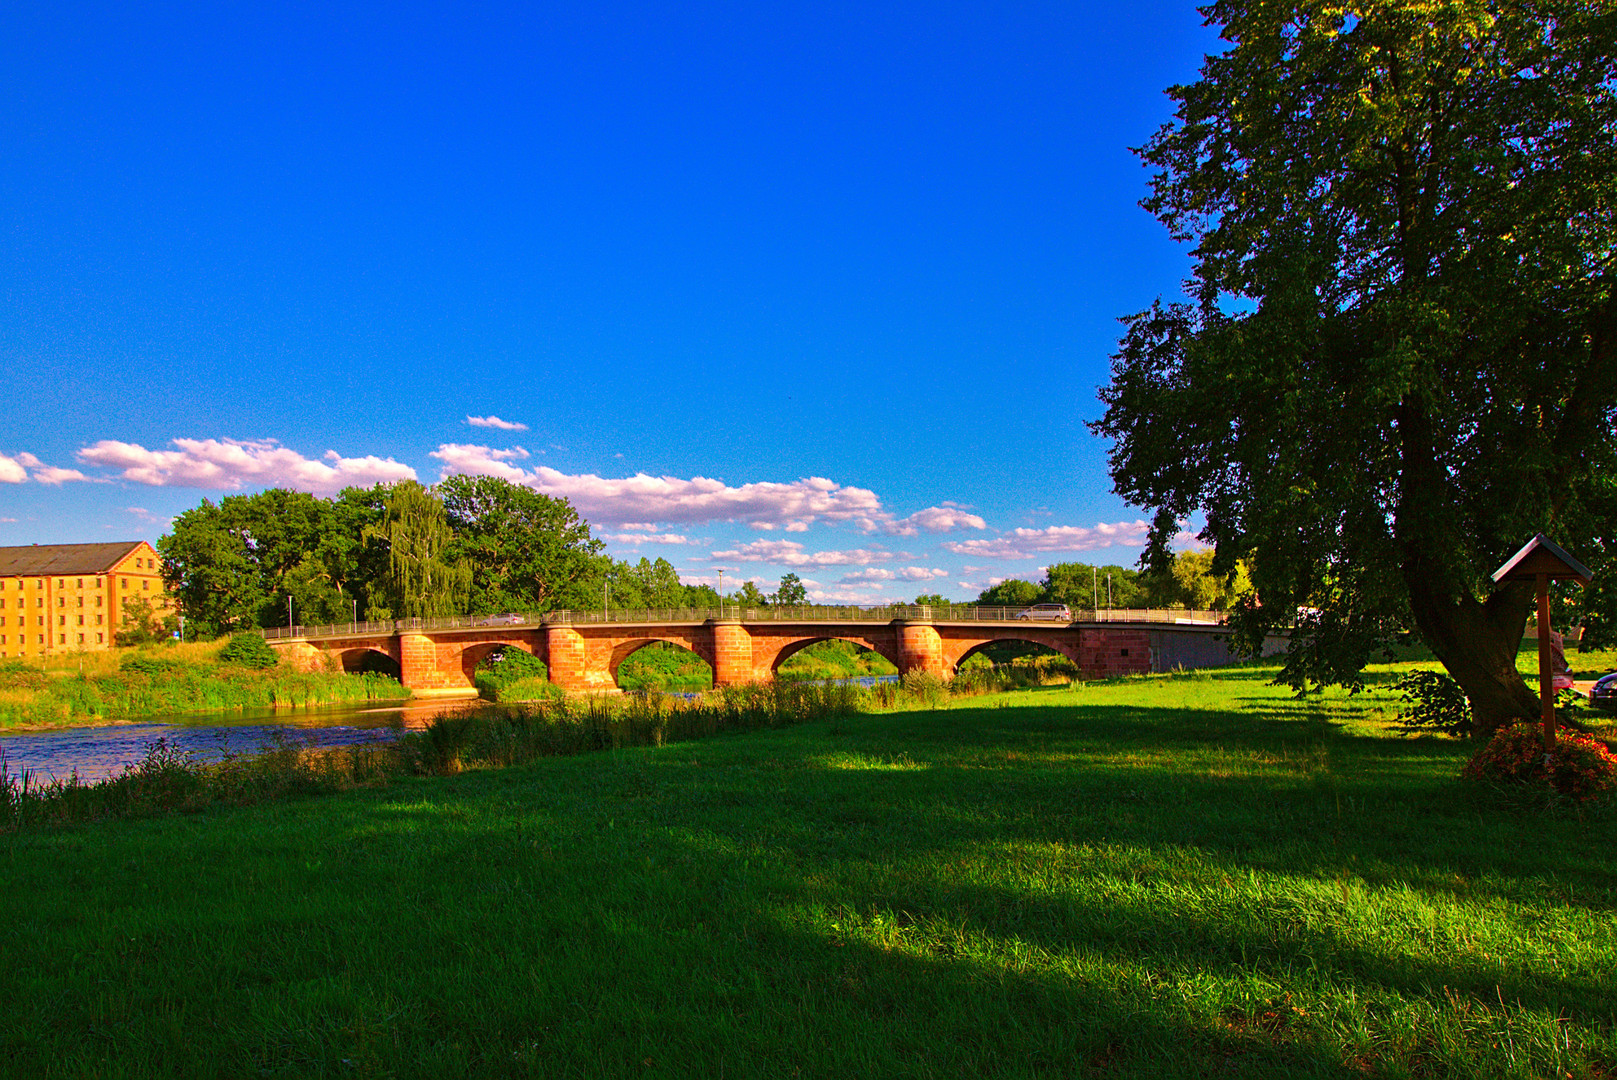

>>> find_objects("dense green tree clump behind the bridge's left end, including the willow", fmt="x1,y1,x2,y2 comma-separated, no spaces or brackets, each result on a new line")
157,475,718,635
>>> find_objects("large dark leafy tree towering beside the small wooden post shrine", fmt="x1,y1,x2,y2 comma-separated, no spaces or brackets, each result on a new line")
1095,0,1617,732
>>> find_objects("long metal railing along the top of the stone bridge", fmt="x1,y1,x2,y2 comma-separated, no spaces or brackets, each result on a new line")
260,605,1224,640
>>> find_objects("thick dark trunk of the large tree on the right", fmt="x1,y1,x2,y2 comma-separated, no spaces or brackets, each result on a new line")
1407,580,1539,739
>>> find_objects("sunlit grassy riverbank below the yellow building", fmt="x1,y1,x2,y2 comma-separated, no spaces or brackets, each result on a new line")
0,642,409,731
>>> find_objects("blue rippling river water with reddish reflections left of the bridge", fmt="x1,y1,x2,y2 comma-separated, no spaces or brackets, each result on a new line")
0,698,467,781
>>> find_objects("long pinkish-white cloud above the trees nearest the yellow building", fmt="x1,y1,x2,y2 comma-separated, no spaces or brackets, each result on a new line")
78,438,416,495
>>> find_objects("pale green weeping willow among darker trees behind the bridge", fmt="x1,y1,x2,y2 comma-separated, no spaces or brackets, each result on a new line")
365,480,472,619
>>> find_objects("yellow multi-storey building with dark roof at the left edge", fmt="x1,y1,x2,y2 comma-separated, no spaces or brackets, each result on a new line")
0,540,170,660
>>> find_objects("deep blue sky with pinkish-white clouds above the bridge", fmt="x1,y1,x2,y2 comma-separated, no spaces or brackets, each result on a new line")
0,3,1218,601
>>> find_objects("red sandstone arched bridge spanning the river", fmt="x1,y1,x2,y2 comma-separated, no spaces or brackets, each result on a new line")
264,606,1232,695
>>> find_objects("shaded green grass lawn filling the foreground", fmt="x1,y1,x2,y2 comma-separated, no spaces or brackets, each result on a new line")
0,668,1617,1077
